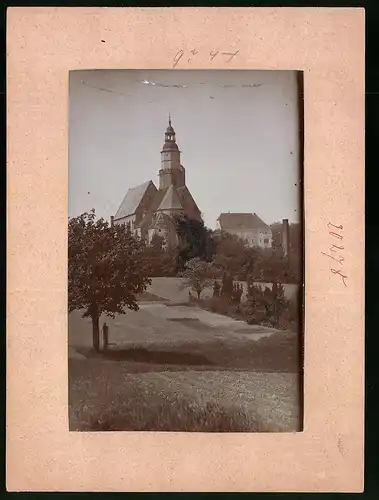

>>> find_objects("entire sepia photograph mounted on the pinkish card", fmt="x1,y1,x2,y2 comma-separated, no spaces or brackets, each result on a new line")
68,69,304,432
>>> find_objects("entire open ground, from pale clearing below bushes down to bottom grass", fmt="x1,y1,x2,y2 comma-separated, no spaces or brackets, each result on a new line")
69,282,300,432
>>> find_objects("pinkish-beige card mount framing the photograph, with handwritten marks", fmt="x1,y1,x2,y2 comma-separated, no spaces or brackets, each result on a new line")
7,8,364,492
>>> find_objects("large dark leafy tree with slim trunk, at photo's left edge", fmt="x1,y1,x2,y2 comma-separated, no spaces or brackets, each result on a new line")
68,210,150,350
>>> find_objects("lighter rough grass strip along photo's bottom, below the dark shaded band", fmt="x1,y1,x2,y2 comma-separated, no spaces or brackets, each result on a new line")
69,360,298,432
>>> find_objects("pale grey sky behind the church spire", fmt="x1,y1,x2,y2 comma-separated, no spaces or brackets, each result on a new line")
69,69,300,229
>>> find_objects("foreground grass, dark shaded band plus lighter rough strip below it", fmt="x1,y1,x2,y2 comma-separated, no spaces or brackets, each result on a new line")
69,335,299,432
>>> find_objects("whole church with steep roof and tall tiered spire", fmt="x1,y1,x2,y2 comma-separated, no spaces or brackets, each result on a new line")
111,117,201,246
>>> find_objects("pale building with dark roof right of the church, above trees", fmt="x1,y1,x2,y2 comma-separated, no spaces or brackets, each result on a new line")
217,212,272,248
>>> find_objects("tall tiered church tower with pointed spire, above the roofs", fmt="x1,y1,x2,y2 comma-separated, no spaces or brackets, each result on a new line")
159,116,186,189
